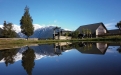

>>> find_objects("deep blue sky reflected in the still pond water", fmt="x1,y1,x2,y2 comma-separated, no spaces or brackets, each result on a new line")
0,46,121,75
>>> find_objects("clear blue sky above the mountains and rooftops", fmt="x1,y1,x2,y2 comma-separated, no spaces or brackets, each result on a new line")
0,0,121,30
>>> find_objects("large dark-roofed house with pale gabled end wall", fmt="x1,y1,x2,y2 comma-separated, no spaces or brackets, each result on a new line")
76,23,108,37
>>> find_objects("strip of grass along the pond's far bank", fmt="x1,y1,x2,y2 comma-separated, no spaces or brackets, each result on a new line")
0,36,121,50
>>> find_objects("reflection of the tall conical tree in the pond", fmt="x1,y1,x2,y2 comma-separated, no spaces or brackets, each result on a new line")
22,47,35,75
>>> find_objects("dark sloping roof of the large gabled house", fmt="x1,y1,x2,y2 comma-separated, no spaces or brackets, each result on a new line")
76,22,108,33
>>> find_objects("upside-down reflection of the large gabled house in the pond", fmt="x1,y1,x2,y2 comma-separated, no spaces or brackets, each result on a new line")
78,43,108,54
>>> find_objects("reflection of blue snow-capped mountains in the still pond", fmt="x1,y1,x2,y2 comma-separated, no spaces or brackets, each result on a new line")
0,44,72,63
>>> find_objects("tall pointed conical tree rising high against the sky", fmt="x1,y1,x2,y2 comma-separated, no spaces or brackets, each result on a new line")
20,6,34,39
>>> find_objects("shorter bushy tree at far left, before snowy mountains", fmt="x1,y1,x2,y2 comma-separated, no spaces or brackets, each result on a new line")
2,21,16,38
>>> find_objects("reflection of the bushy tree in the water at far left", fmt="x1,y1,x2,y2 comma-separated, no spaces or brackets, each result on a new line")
1,49,18,66
